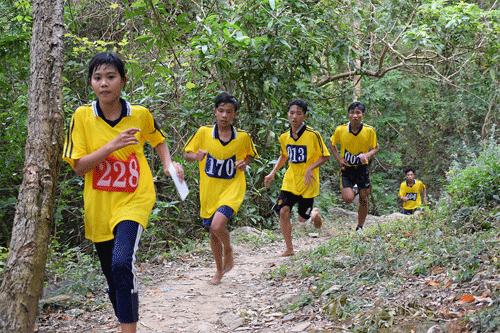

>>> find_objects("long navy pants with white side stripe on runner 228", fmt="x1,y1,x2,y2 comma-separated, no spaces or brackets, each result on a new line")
94,221,144,324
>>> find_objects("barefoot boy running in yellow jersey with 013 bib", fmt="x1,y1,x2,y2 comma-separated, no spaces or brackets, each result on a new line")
264,99,330,257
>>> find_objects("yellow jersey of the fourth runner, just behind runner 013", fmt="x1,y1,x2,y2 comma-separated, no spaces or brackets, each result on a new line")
330,123,378,165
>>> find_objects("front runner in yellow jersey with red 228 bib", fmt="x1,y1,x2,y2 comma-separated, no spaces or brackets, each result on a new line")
63,52,184,333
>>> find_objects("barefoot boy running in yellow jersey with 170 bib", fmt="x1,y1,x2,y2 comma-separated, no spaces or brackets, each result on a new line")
184,93,258,285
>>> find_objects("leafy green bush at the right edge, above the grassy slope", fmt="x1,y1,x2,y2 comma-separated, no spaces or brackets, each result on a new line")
447,131,500,207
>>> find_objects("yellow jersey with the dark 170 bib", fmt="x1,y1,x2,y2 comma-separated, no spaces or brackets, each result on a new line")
184,124,259,219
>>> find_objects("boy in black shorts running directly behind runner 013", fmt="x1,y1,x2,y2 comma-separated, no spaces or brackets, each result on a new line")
329,102,379,231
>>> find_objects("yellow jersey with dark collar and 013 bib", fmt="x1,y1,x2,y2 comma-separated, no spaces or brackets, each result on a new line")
279,125,330,198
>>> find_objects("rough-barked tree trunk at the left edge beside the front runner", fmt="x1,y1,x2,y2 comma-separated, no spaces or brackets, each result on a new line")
0,0,64,333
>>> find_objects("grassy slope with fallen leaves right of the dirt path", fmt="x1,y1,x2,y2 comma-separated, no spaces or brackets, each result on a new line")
280,206,500,332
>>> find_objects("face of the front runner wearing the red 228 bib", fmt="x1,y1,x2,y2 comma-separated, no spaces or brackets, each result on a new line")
90,64,127,103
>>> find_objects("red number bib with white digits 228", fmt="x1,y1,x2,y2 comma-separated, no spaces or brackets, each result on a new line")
92,154,140,193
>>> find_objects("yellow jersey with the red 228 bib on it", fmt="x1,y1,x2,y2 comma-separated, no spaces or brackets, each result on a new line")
63,99,165,242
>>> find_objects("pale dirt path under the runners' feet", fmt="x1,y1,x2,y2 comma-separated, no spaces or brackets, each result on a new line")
35,219,340,333
